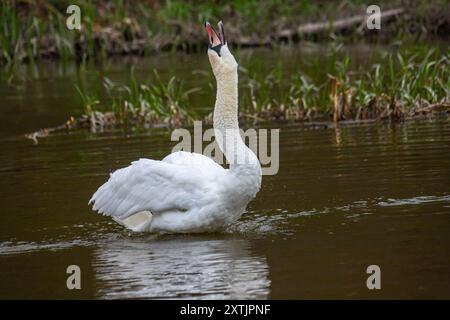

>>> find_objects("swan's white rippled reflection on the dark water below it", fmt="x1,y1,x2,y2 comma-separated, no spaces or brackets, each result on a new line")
94,238,270,299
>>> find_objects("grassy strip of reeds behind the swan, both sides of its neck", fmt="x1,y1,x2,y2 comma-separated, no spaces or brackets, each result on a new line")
26,46,450,143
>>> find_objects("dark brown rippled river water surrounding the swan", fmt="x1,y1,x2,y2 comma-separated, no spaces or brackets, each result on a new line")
0,45,450,299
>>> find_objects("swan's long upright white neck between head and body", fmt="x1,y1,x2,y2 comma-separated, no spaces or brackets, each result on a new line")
214,68,261,190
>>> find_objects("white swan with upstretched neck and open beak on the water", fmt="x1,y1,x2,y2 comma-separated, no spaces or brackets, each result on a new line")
89,22,262,233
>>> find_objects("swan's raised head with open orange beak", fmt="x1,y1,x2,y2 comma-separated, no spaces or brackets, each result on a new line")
205,21,238,77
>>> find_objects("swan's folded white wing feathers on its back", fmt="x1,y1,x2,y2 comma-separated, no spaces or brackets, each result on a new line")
90,152,225,220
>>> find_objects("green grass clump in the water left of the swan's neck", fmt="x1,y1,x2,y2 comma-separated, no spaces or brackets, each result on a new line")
76,66,198,130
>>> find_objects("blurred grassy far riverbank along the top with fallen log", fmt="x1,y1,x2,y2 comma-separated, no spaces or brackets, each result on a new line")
0,0,450,64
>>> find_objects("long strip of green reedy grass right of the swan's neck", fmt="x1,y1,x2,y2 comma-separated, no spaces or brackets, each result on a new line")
241,48,450,121
